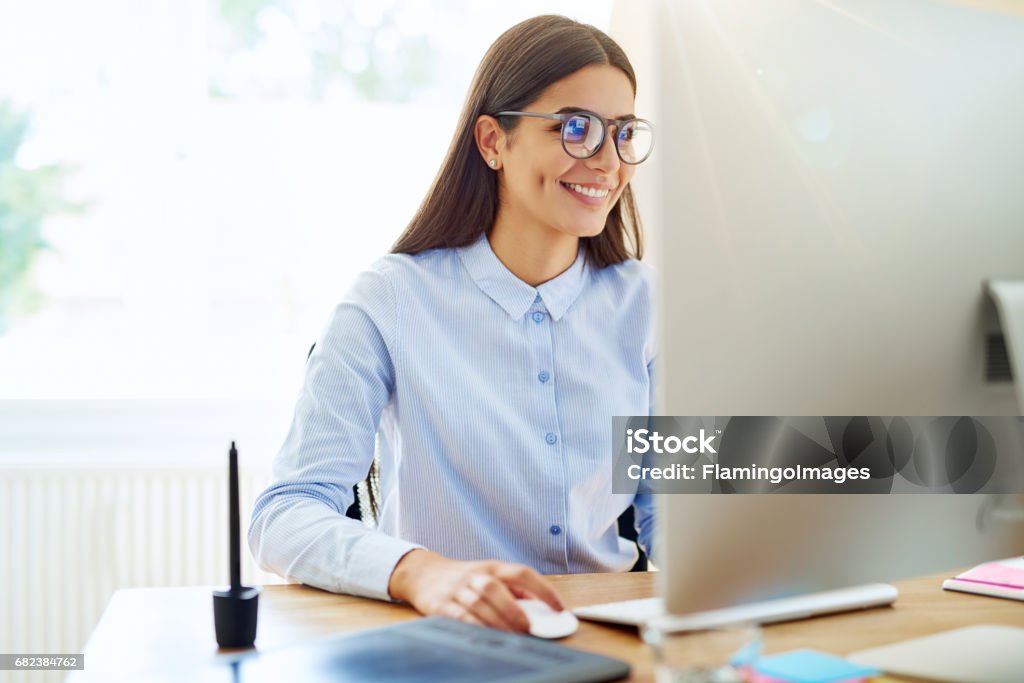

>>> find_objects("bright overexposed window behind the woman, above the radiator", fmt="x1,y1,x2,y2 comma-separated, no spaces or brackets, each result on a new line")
0,0,611,402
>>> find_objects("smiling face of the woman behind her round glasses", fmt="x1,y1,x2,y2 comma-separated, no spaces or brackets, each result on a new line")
499,65,635,237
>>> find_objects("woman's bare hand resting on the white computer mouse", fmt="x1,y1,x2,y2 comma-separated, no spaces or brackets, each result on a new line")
388,549,562,633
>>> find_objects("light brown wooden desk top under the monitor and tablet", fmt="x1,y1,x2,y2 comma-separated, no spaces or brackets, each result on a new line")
68,572,1024,683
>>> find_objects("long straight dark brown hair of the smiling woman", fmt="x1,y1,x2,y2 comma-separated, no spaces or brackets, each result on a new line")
391,14,643,268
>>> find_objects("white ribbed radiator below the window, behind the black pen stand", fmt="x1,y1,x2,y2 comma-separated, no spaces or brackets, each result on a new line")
0,466,282,683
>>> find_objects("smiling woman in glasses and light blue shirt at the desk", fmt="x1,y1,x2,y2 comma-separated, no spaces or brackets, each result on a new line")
249,16,653,631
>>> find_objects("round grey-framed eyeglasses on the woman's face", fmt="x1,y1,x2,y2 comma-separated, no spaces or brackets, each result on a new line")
494,111,654,164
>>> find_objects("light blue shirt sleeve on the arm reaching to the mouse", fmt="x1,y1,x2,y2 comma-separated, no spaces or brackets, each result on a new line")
249,269,422,600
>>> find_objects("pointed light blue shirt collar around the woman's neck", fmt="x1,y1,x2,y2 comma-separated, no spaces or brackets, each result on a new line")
459,233,586,321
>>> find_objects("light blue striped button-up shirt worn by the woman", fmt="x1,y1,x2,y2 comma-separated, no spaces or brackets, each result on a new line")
249,237,654,599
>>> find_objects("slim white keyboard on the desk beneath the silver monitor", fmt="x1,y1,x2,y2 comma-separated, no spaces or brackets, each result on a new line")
572,584,899,631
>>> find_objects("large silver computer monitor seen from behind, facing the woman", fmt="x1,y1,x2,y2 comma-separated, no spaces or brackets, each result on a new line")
612,0,1024,613
